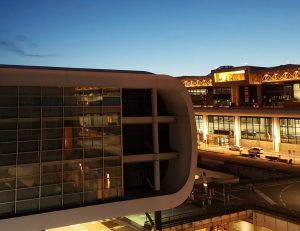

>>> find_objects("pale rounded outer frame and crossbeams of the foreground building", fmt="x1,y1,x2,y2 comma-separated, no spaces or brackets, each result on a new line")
0,65,197,231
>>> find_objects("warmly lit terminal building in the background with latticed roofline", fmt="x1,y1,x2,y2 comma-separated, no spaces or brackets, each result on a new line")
179,64,300,156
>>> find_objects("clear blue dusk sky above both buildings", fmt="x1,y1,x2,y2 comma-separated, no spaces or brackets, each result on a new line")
0,0,300,76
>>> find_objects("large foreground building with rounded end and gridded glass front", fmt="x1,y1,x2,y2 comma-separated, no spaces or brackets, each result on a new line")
0,65,197,231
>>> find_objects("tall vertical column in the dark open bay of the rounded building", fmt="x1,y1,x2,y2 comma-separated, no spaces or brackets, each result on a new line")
151,89,160,191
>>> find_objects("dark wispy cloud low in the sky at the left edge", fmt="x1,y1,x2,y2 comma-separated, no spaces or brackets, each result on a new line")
0,34,57,58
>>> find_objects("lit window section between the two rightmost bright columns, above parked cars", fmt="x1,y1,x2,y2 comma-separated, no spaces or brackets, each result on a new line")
241,116,273,141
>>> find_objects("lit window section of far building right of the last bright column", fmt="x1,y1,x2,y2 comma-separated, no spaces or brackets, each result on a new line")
280,118,300,144
